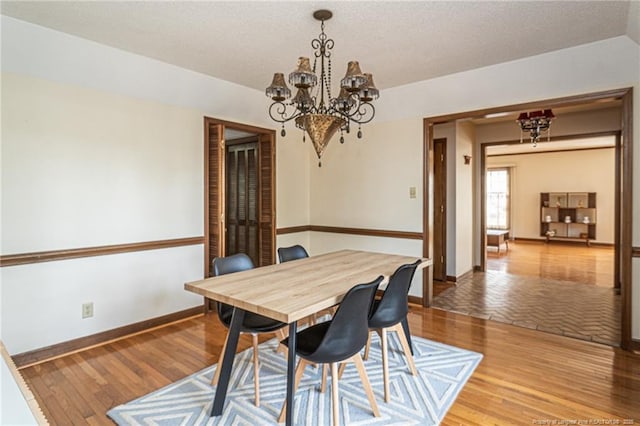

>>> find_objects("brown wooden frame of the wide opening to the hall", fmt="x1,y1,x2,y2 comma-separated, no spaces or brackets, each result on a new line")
423,87,633,350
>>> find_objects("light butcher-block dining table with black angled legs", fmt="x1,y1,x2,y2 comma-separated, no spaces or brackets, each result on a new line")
184,250,431,425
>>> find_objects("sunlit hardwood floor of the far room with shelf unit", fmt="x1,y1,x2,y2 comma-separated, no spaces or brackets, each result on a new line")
487,240,614,287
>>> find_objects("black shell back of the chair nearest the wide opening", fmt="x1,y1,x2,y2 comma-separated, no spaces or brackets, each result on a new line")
369,260,422,328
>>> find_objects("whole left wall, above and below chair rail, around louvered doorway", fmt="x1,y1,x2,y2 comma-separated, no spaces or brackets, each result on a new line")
0,16,309,354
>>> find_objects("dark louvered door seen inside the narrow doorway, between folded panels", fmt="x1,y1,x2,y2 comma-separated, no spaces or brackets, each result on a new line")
225,142,261,265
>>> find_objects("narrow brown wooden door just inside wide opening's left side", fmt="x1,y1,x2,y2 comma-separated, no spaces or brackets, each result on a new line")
433,139,447,282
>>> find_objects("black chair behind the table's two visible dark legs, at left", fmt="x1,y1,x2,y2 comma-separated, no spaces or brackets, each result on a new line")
211,253,286,407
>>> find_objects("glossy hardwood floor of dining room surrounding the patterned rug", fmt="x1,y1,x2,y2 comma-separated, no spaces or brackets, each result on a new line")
21,305,640,425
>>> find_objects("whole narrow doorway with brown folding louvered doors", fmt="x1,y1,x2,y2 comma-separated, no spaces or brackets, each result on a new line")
204,117,276,277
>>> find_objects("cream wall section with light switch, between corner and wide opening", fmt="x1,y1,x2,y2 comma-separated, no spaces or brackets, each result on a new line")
309,120,423,232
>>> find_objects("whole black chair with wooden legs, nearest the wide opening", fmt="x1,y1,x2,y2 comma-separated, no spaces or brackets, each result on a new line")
364,260,422,402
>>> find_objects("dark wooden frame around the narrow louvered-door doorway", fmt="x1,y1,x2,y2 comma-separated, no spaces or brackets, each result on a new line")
203,116,276,277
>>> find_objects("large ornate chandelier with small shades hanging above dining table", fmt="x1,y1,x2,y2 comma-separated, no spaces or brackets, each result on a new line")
265,10,380,167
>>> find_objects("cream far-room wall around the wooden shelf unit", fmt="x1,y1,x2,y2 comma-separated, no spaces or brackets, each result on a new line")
487,148,615,244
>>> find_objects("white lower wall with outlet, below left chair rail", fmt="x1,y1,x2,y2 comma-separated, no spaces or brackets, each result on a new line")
2,245,204,353
